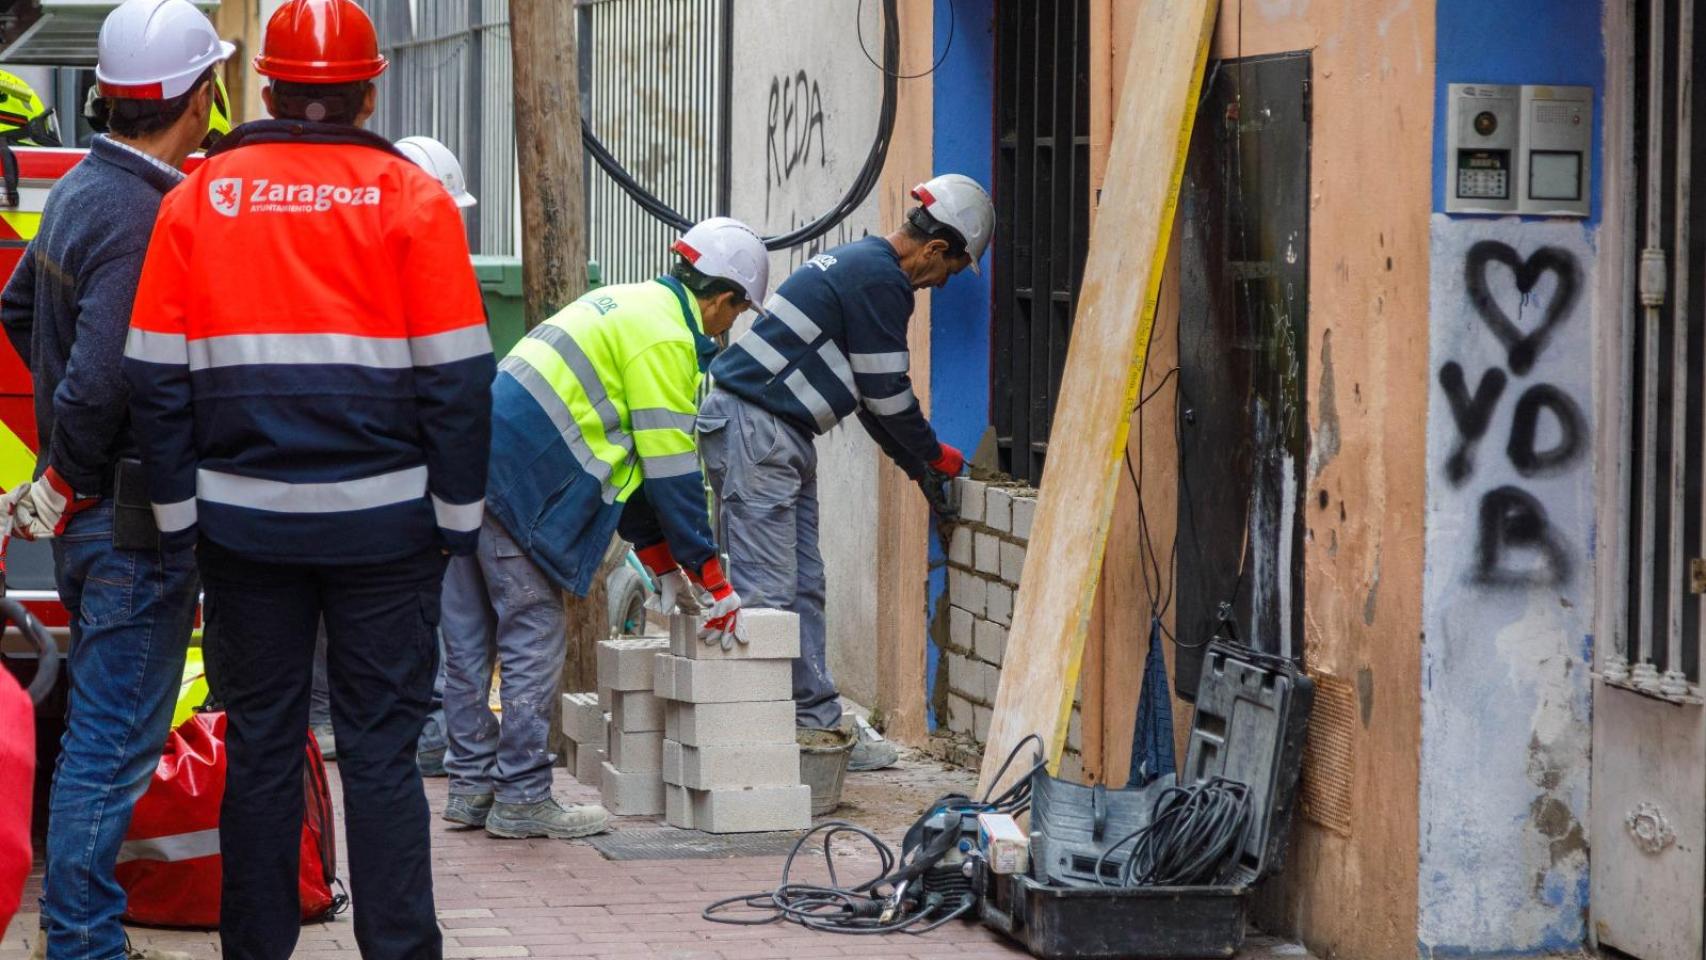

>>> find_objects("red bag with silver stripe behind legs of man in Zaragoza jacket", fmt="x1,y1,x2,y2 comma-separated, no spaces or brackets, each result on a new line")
116,713,346,929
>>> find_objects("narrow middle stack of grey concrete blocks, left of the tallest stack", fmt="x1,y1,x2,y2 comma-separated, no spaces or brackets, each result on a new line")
599,636,669,817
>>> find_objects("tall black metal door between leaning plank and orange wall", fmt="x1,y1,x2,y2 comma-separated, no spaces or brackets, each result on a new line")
1174,53,1310,697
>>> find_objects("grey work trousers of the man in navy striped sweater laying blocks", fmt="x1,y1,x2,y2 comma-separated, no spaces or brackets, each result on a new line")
698,390,841,726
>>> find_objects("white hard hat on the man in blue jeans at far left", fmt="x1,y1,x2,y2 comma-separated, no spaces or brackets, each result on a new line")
96,0,237,101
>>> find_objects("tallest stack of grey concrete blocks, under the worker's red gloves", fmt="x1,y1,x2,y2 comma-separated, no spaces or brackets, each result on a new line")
655,610,812,834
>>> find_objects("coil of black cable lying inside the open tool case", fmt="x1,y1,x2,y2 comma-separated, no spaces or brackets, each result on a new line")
1095,778,1254,887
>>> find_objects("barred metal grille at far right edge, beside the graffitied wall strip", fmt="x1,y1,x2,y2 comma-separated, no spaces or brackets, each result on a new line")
1600,0,1706,703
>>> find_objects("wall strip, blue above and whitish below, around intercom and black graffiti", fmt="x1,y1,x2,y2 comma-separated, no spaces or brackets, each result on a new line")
1416,0,1605,958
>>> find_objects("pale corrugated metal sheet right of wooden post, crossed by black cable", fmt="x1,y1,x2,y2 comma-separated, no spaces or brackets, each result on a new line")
580,0,730,283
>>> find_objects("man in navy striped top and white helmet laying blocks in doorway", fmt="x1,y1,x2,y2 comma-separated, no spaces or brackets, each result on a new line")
698,174,995,769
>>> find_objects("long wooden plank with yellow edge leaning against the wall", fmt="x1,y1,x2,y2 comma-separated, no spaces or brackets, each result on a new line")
978,0,1218,793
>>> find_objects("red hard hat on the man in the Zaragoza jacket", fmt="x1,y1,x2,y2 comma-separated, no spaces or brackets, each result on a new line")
254,0,387,84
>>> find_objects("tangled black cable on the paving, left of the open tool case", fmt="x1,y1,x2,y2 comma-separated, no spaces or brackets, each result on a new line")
699,733,1047,934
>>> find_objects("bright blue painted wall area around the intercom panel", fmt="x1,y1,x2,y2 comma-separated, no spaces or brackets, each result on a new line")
1433,0,1605,222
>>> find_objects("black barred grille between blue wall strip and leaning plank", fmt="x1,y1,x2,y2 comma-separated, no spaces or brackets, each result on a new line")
989,0,1090,483
